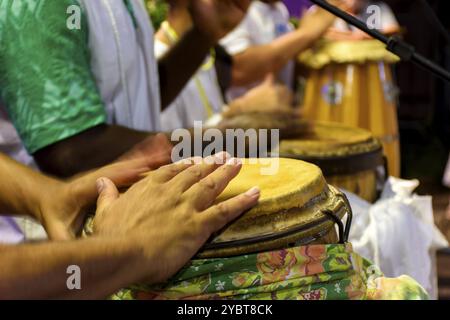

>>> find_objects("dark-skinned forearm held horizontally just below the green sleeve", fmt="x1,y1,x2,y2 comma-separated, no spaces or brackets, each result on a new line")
34,125,150,177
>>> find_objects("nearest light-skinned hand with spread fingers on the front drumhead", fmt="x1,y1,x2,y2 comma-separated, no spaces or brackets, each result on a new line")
94,153,260,283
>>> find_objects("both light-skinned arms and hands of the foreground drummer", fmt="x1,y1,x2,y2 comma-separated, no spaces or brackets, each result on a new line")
0,154,259,299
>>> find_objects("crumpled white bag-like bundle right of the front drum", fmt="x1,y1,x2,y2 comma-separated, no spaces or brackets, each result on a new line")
346,177,448,299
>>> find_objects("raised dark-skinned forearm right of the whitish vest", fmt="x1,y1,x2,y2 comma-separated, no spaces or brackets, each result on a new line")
158,28,214,110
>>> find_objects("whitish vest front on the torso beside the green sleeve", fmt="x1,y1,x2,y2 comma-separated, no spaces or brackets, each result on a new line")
80,0,160,131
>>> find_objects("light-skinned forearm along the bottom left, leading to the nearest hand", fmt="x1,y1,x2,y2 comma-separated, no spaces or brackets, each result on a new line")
0,237,145,299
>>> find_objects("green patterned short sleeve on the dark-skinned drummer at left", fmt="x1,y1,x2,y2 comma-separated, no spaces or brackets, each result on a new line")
0,0,106,153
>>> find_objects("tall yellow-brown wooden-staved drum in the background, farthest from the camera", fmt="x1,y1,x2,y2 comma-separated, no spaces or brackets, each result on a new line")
300,40,400,176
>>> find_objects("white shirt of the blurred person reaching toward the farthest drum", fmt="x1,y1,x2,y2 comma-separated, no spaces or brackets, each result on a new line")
220,1,294,99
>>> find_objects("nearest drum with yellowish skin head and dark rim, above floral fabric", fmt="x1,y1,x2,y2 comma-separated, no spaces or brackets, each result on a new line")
198,158,351,258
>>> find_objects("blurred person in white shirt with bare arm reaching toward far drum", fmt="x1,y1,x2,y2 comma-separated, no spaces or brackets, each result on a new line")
220,0,344,99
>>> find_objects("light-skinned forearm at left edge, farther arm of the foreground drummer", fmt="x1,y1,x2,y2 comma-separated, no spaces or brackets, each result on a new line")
0,154,62,221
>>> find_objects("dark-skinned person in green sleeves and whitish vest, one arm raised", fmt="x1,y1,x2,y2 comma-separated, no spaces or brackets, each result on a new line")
0,0,250,177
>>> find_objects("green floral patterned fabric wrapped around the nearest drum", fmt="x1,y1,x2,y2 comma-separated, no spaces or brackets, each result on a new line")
112,244,428,300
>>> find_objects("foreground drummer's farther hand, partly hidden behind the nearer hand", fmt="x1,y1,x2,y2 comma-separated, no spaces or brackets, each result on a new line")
39,158,157,241
